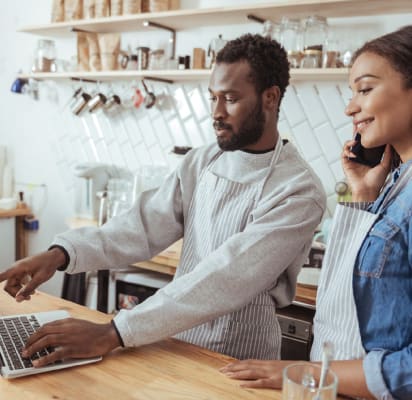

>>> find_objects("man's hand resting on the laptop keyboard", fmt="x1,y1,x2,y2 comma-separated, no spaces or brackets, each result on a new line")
22,318,121,367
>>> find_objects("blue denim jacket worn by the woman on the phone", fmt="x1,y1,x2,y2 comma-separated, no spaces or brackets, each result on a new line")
353,163,412,400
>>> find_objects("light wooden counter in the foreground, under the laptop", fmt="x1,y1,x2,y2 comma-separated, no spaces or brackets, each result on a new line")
0,289,282,400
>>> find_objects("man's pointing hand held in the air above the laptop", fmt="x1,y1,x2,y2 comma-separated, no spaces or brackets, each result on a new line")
0,248,65,302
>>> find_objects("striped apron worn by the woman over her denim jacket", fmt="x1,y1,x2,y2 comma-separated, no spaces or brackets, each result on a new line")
310,167,412,361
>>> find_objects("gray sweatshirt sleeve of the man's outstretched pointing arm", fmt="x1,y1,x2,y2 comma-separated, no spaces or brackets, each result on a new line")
52,169,183,273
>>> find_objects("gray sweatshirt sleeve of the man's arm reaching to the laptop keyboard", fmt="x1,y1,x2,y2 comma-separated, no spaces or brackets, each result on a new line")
114,188,323,346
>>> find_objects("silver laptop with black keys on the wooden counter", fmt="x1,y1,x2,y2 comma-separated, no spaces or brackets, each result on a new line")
0,310,102,379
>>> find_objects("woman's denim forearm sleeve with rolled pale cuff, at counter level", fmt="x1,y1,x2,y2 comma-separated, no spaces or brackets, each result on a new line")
363,346,412,400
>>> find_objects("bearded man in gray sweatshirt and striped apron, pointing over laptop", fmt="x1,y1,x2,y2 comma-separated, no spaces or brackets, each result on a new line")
0,34,325,366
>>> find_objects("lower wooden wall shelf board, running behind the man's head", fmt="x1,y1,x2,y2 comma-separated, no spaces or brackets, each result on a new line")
19,68,348,82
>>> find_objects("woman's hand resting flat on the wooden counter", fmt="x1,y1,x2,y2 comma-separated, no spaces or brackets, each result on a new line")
220,360,293,389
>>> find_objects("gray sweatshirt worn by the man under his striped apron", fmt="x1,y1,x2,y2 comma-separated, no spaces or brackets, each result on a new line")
53,143,325,346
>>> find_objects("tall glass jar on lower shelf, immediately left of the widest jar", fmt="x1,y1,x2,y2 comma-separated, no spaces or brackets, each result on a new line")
280,17,303,68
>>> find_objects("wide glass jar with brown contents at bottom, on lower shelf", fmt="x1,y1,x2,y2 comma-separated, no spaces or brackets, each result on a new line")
301,15,328,68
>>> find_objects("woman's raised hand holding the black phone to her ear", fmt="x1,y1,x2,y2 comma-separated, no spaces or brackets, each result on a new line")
342,140,391,201
